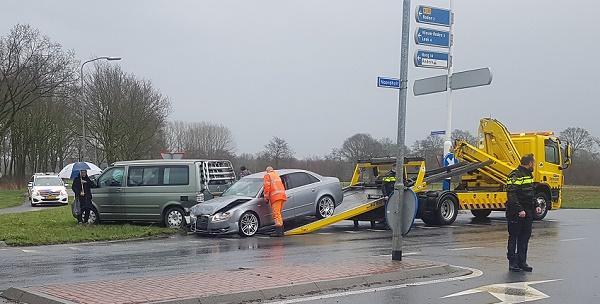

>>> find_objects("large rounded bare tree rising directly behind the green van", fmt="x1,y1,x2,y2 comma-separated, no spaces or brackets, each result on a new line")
79,64,170,164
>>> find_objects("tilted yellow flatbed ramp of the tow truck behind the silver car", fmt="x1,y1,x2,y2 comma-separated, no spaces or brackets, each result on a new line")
285,187,385,235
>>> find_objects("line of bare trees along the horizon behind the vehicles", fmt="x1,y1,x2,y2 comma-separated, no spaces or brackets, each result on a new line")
0,25,600,185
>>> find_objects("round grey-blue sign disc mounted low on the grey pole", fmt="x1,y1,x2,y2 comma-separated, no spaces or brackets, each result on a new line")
385,189,419,235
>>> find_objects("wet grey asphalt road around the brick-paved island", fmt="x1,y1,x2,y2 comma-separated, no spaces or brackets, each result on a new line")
0,210,600,304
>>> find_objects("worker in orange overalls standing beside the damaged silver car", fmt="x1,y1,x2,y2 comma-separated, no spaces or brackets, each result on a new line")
263,167,287,237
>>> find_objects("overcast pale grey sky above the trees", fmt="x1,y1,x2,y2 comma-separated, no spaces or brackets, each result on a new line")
0,0,600,157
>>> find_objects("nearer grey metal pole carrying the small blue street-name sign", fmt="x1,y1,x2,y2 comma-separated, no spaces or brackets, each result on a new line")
388,0,411,261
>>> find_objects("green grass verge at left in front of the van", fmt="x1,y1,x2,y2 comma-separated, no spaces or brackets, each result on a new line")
0,202,177,246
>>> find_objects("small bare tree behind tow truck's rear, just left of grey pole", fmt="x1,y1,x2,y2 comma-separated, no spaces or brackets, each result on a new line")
337,133,386,162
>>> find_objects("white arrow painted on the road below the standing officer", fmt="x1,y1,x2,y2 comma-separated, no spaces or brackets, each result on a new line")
442,280,560,304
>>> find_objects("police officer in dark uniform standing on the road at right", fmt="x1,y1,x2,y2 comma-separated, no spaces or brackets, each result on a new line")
506,154,542,272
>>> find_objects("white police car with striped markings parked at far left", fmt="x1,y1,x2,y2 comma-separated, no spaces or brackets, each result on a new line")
27,173,69,206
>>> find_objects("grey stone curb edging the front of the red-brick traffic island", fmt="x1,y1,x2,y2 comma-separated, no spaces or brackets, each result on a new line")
0,264,471,304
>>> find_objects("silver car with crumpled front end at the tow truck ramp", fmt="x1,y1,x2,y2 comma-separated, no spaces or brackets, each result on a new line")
190,169,344,237
